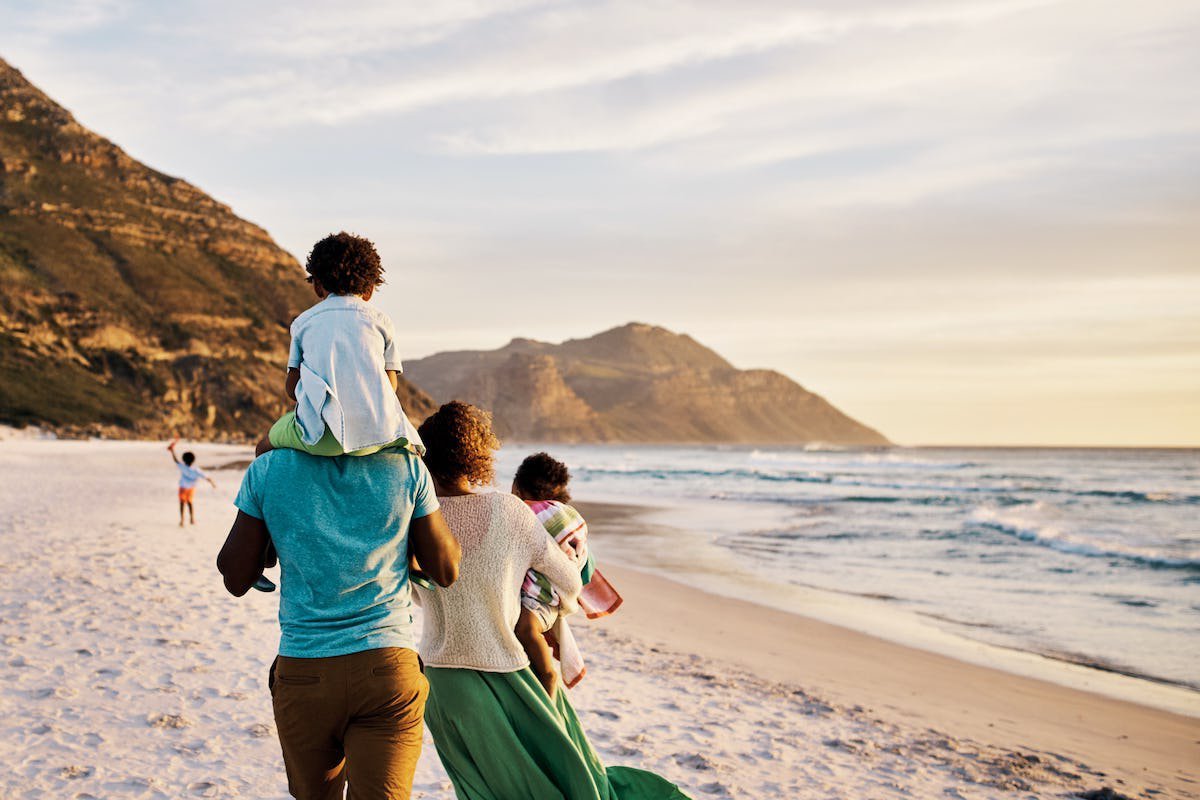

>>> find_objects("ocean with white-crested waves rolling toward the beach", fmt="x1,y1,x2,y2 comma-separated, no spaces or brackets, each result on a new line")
498,445,1200,705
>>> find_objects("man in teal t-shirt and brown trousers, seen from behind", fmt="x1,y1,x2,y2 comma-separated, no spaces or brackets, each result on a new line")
217,449,461,800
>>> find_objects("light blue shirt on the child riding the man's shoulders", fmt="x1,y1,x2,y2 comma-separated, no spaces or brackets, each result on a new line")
288,295,421,452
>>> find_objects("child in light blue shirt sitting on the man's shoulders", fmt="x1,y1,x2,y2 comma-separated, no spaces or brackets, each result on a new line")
257,231,425,456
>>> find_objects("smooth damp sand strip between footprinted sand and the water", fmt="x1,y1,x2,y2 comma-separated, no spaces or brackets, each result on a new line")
576,501,1200,796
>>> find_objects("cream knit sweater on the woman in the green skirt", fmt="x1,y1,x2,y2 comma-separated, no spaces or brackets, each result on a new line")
416,492,582,672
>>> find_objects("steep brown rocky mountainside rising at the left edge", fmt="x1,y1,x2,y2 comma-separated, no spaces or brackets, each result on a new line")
0,60,432,439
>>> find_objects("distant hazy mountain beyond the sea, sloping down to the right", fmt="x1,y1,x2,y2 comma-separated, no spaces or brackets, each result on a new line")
406,323,888,445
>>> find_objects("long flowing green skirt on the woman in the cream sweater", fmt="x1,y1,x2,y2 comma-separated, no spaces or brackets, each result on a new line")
425,667,688,800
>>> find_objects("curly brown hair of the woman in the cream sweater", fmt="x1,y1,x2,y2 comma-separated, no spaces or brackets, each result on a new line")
418,401,500,486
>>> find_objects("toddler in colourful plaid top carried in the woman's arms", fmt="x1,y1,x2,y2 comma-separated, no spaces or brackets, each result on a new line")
512,452,622,694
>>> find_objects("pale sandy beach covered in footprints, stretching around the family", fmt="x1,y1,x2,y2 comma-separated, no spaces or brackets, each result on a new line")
0,439,1200,800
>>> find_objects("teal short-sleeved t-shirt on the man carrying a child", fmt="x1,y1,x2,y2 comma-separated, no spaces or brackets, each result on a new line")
234,449,438,658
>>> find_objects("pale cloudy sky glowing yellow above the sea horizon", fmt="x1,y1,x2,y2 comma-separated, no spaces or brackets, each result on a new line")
0,0,1200,446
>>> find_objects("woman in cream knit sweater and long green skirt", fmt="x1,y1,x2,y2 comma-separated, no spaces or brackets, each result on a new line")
418,402,686,800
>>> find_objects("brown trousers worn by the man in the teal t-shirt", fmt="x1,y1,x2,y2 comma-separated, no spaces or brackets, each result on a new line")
271,648,430,800
